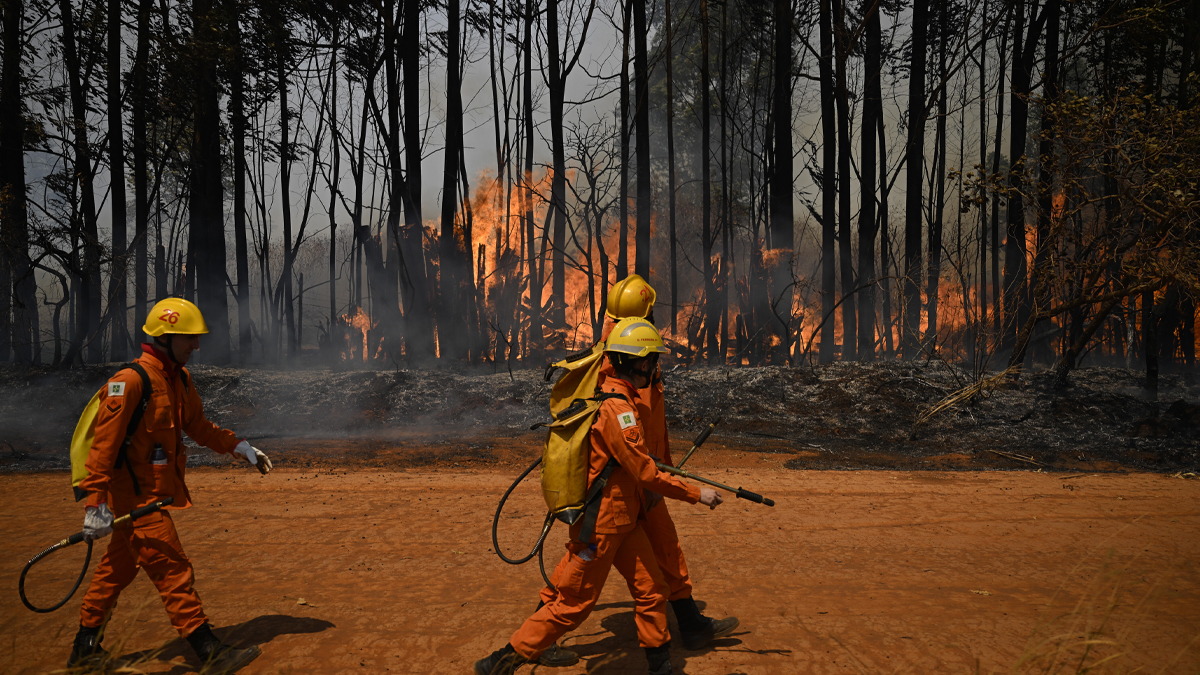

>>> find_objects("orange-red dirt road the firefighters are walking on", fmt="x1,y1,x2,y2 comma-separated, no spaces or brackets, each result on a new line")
0,450,1200,675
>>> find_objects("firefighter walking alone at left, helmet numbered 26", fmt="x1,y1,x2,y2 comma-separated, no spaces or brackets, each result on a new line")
67,298,271,674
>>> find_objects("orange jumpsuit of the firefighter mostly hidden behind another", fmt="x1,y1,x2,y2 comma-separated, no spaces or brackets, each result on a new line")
599,318,691,601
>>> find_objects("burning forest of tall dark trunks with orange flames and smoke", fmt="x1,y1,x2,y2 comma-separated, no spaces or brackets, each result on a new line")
0,2,1200,392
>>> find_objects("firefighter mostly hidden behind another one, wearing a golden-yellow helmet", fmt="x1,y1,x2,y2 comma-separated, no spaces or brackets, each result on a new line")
600,274,738,650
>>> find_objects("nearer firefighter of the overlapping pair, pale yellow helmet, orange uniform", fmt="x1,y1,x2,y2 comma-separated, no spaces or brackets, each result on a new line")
475,318,722,675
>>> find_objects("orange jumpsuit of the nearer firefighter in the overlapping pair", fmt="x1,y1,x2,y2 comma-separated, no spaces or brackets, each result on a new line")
509,377,700,659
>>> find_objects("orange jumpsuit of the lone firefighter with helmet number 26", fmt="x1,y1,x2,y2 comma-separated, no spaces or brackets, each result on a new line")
79,345,239,637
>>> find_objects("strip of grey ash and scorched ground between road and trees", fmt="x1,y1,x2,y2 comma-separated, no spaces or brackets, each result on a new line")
0,360,1200,473
